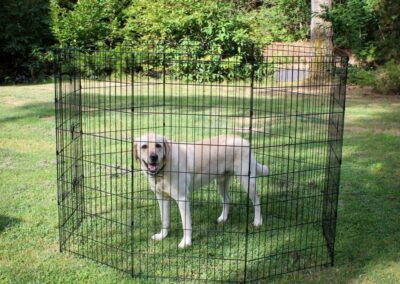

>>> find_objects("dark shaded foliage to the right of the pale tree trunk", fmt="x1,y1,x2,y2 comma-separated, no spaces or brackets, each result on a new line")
324,0,400,64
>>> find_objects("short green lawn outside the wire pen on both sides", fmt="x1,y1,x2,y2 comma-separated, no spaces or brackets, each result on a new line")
0,84,400,283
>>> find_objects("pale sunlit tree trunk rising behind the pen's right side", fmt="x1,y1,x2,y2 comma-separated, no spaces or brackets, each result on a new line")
310,0,333,49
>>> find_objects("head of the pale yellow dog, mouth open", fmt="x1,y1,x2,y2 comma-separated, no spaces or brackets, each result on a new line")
133,133,169,176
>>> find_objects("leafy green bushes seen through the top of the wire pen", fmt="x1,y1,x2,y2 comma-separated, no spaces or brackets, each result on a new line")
67,44,274,82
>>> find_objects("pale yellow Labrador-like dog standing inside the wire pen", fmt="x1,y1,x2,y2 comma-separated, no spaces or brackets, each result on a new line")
133,133,268,248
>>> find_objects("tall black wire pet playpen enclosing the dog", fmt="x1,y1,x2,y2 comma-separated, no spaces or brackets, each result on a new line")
55,45,347,282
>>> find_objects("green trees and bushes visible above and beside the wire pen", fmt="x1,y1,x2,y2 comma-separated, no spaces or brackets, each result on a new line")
0,0,400,90
